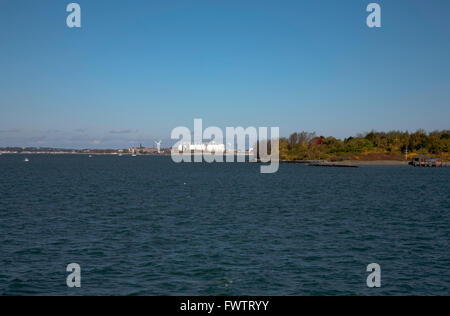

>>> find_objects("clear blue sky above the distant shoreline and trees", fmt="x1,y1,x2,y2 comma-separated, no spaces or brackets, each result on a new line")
0,0,450,148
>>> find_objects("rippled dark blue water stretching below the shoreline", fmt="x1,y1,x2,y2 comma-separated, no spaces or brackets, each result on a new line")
0,155,450,295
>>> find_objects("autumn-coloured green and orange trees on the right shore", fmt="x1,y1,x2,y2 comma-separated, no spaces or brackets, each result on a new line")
257,129,450,161
